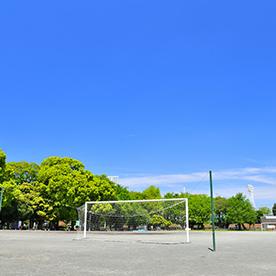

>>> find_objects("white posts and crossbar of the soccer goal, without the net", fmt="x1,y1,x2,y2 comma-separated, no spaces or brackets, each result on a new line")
83,198,190,242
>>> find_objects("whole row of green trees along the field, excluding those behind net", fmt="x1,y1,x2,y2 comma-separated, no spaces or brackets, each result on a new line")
0,149,276,229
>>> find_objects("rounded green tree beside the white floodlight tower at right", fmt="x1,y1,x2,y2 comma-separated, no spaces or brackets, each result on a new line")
226,193,257,229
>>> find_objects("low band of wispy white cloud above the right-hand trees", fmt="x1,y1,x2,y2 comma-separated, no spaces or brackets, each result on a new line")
120,167,276,208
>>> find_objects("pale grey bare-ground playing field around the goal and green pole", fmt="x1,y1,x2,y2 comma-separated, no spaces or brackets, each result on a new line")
0,230,276,276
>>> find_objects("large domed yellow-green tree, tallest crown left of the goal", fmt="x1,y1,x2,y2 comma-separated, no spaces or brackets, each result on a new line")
38,157,115,223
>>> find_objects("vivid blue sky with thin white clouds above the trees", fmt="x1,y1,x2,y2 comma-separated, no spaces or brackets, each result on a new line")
0,0,276,208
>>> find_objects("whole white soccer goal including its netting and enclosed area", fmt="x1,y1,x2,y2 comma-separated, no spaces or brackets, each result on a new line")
78,198,189,243
